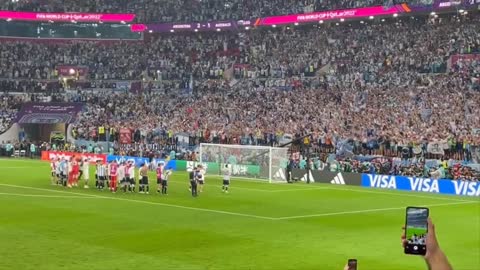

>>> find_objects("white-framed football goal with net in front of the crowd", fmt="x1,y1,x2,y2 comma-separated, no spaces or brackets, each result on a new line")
199,143,288,183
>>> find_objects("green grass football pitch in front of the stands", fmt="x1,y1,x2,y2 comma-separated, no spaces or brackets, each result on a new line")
0,159,480,270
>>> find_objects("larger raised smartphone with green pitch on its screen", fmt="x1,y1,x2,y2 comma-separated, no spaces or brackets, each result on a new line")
405,207,429,255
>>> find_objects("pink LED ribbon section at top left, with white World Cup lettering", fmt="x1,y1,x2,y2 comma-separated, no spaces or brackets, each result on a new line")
0,10,135,23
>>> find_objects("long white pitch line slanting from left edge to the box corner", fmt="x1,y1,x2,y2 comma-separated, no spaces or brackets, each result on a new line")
0,184,276,220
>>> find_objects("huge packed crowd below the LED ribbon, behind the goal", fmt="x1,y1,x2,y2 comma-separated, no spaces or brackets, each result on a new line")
0,14,480,179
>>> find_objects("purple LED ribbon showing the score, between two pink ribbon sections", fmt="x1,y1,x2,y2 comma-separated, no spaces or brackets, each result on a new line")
130,20,255,33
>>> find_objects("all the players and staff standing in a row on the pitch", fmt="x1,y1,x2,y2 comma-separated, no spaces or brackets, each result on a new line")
50,157,231,197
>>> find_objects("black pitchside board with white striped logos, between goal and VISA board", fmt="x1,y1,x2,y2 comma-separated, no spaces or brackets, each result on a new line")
290,169,362,186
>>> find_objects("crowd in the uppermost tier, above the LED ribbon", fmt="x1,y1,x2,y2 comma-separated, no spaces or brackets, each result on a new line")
0,0,393,22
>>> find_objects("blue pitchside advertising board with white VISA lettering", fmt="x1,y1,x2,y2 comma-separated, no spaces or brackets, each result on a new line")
362,174,480,197
